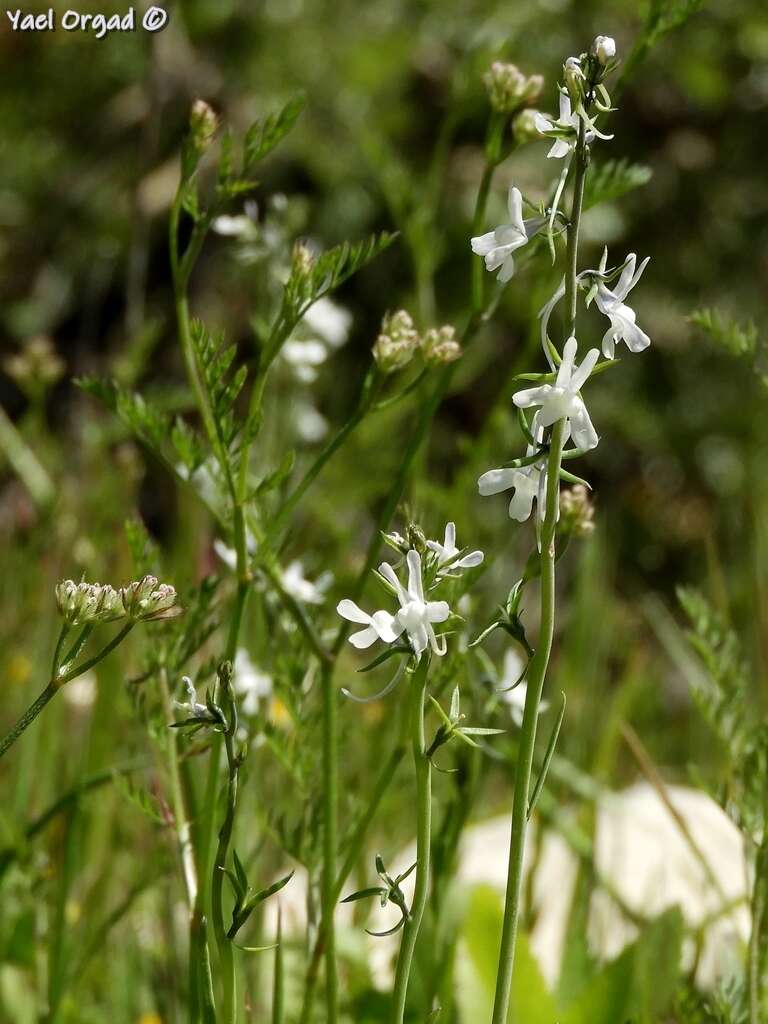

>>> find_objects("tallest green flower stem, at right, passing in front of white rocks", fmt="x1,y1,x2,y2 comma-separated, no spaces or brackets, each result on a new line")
493,112,588,1024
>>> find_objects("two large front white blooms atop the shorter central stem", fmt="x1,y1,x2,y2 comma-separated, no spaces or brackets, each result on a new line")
336,549,451,657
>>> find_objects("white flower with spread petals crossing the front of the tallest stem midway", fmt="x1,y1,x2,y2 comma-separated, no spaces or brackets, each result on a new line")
512,337,600,451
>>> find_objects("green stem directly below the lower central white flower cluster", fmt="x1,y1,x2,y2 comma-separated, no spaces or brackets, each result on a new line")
392,654,432,1024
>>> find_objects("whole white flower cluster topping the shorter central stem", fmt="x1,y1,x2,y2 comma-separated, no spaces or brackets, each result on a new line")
336,522,483,657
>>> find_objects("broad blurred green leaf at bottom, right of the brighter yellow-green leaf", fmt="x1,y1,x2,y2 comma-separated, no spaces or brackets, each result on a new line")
559,907,683,1024
